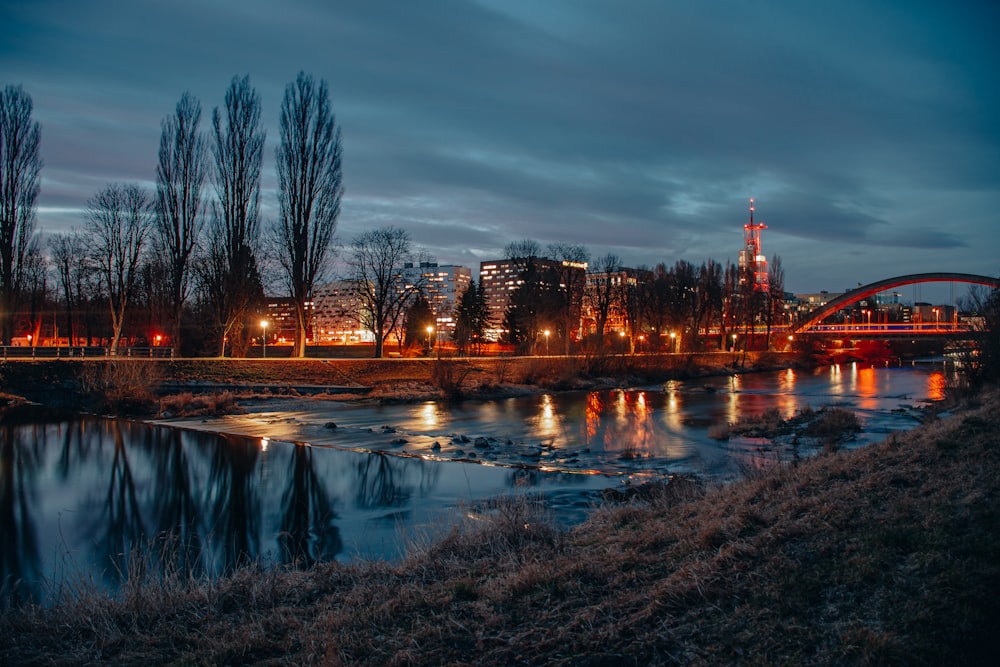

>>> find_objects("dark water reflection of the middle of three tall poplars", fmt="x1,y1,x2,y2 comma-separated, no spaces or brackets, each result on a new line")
206,433,260,572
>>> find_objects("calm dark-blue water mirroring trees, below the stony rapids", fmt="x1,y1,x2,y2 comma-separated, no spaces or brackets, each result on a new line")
0,414,614,607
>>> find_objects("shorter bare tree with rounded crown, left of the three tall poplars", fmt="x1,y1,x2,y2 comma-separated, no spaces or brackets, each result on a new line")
85,183,152,354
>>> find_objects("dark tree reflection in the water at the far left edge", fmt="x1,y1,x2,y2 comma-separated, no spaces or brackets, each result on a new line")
0,423,44,609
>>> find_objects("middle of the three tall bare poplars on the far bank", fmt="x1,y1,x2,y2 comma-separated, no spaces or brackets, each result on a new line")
202,76,265,356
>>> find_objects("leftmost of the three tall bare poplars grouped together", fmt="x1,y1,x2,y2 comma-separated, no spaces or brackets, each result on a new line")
156,93,206,353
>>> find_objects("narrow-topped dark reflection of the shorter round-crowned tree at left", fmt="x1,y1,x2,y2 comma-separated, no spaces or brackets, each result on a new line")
91,419,145,580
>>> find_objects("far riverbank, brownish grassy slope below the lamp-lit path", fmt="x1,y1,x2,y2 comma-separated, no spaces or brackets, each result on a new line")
0,352,797,414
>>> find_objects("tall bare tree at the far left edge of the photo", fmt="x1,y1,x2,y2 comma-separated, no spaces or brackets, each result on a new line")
0,86,42,345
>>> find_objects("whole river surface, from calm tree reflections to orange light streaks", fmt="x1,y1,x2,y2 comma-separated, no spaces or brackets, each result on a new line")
0,363,945,606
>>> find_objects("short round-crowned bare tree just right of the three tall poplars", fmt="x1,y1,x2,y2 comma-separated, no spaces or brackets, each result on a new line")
351,226,423,359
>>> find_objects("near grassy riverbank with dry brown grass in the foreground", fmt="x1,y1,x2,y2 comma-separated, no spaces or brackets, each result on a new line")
0,384,1000,665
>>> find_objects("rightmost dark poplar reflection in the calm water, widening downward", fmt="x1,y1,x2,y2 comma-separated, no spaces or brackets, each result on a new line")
278,445,343,567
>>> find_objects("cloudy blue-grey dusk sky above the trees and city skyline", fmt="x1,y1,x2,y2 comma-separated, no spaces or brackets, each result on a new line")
0,0,1000,292
